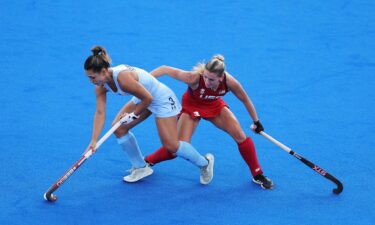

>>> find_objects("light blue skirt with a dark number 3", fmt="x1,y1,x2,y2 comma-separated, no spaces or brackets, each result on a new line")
131,83,181,118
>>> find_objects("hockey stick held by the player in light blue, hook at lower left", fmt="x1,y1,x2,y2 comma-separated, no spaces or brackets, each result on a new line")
44,117,126,202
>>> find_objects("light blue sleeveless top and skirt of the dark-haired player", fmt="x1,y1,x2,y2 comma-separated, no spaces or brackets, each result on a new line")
104,65,181,117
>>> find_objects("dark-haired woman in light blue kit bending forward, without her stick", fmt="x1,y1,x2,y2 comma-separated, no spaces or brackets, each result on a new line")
84,46,214,184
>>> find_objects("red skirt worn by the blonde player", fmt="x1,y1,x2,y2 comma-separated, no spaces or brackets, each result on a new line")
181,92,229,119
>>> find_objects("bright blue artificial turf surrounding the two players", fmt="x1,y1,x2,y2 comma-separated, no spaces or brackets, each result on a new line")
0,0,375,225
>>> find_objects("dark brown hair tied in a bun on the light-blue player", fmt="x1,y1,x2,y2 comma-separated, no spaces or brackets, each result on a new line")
84,45,111,72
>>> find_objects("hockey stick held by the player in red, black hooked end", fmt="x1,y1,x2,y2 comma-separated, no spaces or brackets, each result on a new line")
260,131,344,195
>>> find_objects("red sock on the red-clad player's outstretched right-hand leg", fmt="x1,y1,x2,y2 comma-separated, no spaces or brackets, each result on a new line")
238,137,263,177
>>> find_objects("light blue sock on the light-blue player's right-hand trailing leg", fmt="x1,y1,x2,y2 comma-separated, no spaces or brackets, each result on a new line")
176,141,208,167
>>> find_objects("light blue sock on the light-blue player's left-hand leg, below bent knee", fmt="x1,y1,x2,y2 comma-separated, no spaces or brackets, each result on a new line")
117,132,146,168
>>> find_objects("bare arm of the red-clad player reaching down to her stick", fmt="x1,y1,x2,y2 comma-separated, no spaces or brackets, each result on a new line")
227,73,259,122
